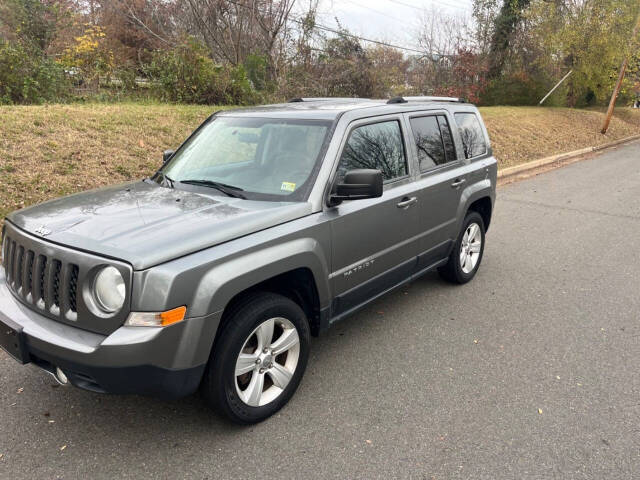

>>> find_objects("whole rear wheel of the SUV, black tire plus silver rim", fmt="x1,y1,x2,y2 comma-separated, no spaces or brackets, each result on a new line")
438,211,485,285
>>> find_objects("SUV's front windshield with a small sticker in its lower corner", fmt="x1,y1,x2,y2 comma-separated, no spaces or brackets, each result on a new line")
156,117,331,201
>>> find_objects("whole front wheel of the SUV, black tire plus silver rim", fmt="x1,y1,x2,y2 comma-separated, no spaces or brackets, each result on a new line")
201,293,310,425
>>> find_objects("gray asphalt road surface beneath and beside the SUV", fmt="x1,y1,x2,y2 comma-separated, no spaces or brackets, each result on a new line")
0,143,640,479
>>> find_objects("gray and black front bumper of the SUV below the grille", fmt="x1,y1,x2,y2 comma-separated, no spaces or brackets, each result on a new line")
0,268,221,398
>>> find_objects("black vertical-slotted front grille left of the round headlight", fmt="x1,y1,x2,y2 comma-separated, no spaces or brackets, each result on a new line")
3,236,79,320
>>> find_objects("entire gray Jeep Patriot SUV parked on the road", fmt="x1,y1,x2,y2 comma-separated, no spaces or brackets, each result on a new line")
0,97,497,424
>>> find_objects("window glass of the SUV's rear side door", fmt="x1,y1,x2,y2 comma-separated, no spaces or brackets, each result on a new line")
410,115,457,172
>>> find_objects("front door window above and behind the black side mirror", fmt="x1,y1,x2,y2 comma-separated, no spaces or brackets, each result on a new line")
338,120,407,181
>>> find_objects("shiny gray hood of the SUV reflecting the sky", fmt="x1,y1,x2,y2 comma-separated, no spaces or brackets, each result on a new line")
7,182,311,270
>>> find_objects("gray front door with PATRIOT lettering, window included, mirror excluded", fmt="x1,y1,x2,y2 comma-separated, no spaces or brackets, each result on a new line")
327,115,421,316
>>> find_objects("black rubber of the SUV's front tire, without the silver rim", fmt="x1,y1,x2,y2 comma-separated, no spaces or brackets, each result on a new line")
201,293,310,425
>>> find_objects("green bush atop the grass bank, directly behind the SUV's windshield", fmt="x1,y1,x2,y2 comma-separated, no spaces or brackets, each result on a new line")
146,40,258,105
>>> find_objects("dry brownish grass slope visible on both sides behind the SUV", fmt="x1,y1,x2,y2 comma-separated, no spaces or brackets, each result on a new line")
0,104,640,231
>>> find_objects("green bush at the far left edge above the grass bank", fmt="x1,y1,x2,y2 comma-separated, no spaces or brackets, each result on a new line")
0,40,69,104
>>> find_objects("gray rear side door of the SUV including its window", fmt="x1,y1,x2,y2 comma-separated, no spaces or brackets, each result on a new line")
406,110,467,270
